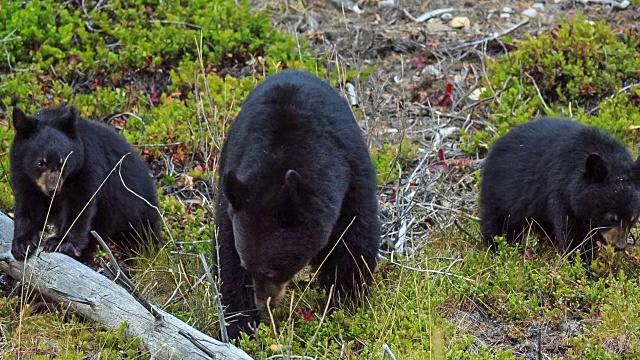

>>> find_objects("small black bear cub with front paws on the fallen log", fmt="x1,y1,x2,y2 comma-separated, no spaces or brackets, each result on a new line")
10,106,162,265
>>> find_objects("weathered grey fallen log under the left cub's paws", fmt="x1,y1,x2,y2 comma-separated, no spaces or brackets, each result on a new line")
0,212,251,359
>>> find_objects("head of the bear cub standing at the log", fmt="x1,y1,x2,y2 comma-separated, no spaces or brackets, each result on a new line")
13,108,84,196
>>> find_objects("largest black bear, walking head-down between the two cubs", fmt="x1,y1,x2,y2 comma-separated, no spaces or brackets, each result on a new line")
214,70,381,338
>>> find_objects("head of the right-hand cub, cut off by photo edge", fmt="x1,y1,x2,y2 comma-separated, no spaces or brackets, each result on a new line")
572,154,640,250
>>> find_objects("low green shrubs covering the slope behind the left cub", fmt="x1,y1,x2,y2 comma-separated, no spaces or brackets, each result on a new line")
0,0,324,211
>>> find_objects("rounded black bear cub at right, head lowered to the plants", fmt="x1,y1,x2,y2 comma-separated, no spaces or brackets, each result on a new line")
480,118,640,262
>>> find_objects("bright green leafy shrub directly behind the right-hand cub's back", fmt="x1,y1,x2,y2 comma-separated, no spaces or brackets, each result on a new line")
463,17,640,153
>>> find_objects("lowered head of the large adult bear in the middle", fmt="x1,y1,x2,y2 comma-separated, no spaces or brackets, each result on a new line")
223,170,329,311
